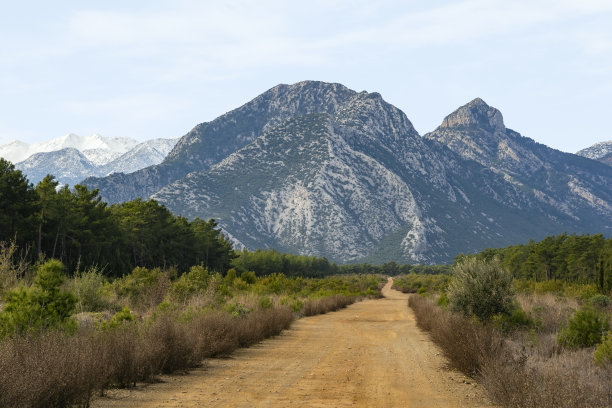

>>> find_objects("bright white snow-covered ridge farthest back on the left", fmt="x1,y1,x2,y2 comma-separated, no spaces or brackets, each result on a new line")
0,133,138,165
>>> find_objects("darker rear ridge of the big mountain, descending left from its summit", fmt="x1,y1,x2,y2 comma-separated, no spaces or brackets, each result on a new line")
84,81,355,203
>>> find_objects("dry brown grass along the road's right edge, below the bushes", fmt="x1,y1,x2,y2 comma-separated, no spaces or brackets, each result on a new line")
409,296,612,408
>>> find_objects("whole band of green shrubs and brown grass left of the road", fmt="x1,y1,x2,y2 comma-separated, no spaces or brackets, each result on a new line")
0,243,384,407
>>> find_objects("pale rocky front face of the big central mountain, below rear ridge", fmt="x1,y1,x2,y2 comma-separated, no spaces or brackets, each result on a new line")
153,87,608,262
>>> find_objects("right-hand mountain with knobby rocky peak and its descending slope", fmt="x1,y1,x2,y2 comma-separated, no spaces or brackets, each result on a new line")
425,99,612,225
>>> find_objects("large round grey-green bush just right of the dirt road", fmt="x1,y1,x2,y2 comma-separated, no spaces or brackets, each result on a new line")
447,257,514,321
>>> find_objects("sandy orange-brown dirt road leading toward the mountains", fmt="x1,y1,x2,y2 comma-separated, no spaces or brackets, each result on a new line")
93,281,492,408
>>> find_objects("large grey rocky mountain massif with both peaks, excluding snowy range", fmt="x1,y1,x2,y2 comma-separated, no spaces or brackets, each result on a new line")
84,81,612,263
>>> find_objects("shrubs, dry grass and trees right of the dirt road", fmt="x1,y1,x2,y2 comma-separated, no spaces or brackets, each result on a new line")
406,235,612,407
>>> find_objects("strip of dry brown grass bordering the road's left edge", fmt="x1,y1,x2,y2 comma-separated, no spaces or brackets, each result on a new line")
0,307,293,407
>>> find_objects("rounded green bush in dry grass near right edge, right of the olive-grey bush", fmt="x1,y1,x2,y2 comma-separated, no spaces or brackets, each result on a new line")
557,305,610,348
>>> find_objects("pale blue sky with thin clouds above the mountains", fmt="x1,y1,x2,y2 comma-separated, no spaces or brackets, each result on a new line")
0,0,612,152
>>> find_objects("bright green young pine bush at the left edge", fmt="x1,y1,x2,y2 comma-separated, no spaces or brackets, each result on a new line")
0,259,76,337
